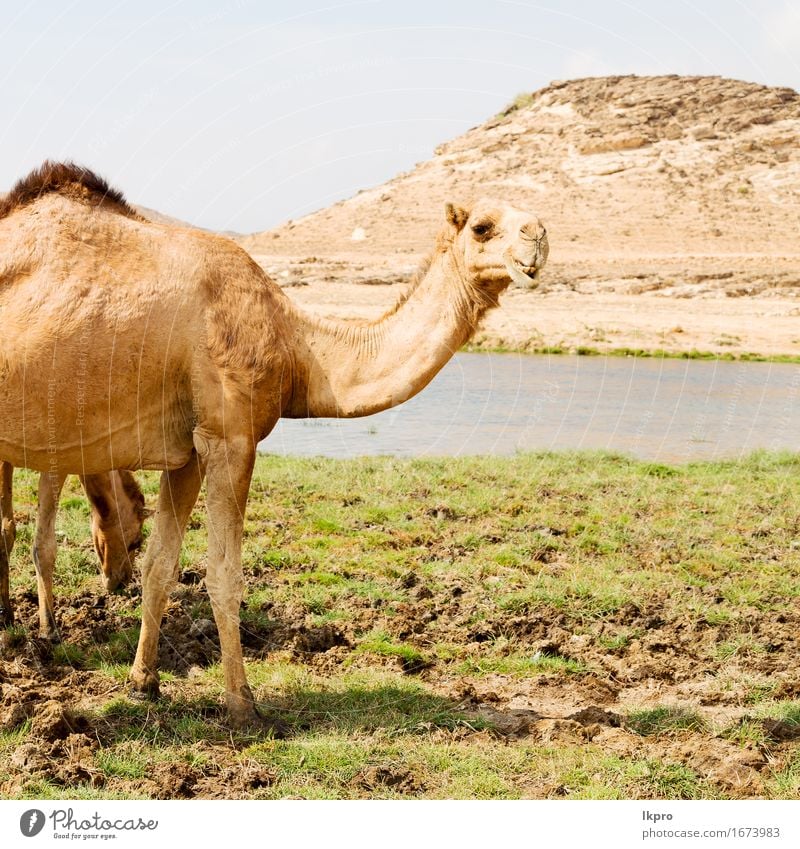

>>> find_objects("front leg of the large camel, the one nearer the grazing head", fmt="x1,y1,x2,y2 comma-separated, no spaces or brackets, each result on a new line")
130,452,204,698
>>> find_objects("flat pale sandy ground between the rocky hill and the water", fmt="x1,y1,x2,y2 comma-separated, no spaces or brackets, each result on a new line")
255,254,800,358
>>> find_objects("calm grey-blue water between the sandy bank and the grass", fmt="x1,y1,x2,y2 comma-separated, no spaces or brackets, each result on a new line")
259,354,800,462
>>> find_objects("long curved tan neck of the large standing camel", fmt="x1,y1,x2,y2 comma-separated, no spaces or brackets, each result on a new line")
284,249,496,418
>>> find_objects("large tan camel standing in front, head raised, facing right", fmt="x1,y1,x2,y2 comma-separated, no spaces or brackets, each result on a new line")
0,162,548,726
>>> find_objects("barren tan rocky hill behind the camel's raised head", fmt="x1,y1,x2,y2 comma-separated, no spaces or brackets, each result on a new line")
242,76,800,304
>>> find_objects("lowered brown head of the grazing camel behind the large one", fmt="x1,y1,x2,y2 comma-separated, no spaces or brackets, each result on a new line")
87,472,146,592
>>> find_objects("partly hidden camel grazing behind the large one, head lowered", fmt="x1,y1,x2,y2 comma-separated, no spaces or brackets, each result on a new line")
0,462,146,642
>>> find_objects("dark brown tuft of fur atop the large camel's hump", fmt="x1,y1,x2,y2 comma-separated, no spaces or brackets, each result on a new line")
0,159,140,218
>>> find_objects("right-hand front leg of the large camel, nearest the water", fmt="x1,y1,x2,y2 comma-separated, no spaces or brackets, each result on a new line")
206,439,258,727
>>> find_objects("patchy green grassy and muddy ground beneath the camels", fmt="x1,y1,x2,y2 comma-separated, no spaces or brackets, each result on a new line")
0,452,800,799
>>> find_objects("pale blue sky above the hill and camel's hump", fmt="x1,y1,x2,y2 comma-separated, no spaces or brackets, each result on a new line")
0,0,800,232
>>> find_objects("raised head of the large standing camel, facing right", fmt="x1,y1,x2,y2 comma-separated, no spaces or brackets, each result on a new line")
446,200,550,295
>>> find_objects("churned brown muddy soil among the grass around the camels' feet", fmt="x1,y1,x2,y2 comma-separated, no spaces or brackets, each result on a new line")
0,576,800,799
